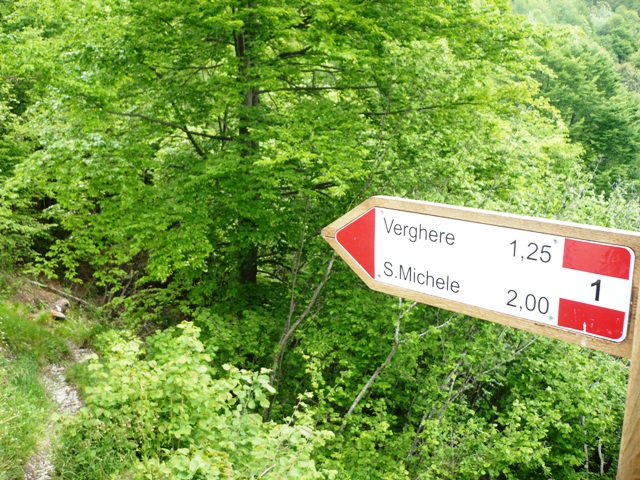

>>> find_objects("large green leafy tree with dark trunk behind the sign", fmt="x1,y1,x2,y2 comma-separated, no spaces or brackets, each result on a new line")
4,0,576,306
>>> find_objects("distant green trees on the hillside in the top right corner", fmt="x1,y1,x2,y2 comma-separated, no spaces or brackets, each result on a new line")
514,0,640,192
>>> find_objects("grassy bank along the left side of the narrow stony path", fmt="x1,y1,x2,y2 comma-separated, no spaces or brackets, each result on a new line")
0,271,107,480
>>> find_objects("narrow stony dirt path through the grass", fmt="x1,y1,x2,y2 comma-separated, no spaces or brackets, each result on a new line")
24,343,92,480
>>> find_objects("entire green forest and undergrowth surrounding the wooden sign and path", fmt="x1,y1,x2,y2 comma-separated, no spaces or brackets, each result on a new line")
0,0,640,480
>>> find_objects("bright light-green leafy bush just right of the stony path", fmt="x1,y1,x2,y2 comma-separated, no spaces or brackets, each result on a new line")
57,323,331,479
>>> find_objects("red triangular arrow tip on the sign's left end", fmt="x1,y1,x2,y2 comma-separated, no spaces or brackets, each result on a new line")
336,208,376,278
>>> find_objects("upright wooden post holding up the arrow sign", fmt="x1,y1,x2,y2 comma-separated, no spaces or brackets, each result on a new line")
616,309,640,480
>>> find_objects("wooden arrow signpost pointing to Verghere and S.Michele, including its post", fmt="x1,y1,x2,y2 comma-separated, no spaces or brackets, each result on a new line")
322,197,640,480
